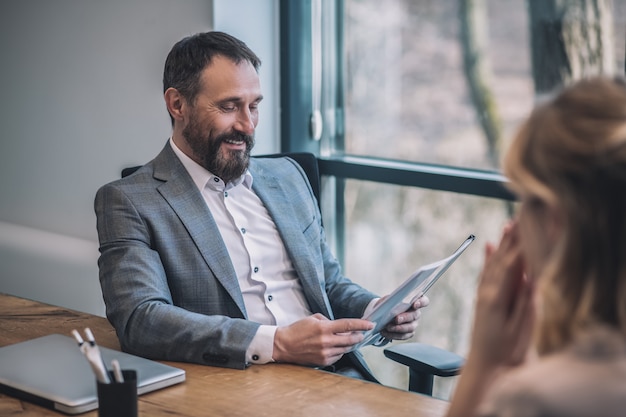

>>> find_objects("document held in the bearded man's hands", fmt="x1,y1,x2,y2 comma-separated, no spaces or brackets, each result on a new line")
353,235,475,350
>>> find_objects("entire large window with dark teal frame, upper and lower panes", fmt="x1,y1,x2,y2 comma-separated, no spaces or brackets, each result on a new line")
281,0,626,398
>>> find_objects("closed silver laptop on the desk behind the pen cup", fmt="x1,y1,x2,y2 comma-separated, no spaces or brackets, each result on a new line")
0,334,185,414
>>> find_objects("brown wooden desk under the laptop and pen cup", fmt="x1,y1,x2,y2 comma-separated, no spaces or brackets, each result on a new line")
0,294,447,417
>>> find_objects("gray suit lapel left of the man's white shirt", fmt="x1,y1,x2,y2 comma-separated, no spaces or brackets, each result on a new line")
154,143,247,318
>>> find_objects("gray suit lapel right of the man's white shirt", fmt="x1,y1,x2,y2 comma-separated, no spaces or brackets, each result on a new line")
250,160,333,319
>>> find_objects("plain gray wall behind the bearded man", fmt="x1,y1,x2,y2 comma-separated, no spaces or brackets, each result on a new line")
0,0,279,315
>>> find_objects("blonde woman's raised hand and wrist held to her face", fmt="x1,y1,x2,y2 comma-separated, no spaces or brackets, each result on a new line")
446,222,535,417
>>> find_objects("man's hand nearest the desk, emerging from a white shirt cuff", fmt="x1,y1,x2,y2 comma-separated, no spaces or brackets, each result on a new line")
272,314,374,366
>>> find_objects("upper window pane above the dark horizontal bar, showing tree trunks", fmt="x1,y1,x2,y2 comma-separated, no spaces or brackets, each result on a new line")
342,0,625,169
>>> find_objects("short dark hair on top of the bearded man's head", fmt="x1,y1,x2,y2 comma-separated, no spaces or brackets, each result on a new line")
163,31,261,123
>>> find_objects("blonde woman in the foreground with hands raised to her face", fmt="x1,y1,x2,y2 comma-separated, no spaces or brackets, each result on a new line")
448,77,626,417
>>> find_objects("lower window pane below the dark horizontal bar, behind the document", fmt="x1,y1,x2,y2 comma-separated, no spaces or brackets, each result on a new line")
345,180,508,398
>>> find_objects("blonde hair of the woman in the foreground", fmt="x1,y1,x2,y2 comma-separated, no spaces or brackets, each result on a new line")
504,77,626,353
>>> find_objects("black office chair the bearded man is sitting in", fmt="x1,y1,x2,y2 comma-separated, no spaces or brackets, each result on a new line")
122,152,464,395
